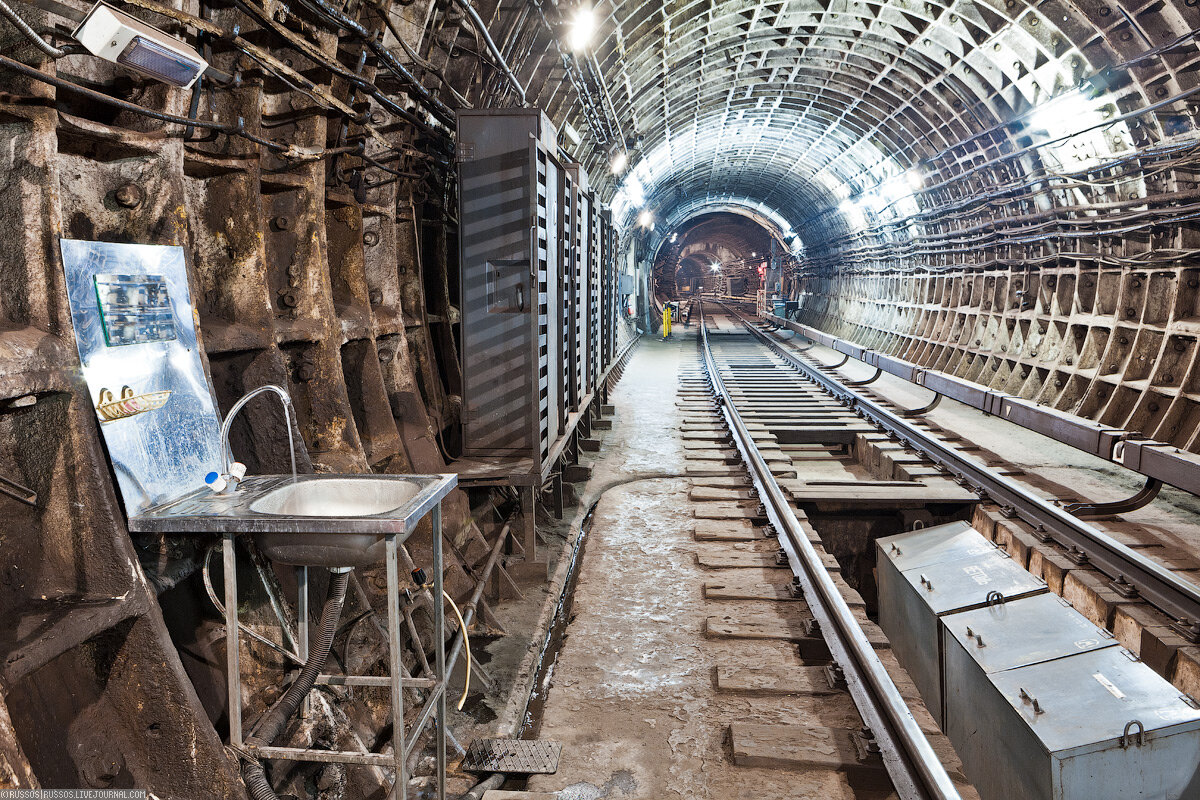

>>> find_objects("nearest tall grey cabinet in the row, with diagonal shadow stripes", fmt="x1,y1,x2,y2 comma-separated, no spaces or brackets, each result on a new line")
457,109,565,462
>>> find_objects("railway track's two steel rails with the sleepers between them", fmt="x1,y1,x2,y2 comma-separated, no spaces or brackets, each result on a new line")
700,306,1200,800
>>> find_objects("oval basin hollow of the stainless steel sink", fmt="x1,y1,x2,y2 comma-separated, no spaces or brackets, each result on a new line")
250,477,420,517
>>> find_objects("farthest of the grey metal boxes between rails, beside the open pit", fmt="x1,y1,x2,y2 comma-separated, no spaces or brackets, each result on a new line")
876,522,1046,727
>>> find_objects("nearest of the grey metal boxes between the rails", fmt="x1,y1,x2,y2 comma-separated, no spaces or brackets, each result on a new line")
946,646,1200,800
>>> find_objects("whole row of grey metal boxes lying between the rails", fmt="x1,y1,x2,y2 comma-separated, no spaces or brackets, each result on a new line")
876,522,1200,800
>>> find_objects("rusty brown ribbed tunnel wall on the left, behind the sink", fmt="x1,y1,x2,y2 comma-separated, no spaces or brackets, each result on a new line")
0,2,511,798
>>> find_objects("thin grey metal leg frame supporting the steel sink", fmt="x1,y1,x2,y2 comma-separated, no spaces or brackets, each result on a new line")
222,499,446,800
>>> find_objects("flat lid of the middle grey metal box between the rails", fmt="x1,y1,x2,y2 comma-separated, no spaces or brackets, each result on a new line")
942,593,1116,673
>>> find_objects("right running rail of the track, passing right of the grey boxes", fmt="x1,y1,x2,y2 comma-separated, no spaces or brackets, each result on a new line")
730,303,1200,642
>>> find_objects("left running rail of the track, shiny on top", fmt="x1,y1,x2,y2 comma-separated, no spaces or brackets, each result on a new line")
700,302,960,800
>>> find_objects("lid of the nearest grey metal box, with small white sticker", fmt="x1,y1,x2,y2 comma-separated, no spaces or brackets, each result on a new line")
990,648,1200,758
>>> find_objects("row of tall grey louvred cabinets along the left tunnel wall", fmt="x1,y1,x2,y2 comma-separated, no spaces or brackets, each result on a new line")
457,109,618,469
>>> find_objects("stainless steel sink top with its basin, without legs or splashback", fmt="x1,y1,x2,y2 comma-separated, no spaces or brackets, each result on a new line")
130,475,457,567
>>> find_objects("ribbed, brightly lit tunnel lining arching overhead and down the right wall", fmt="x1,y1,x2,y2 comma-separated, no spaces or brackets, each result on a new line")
492,0,1200,453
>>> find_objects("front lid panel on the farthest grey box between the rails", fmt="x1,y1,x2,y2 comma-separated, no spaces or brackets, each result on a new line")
900,548,1046,615
